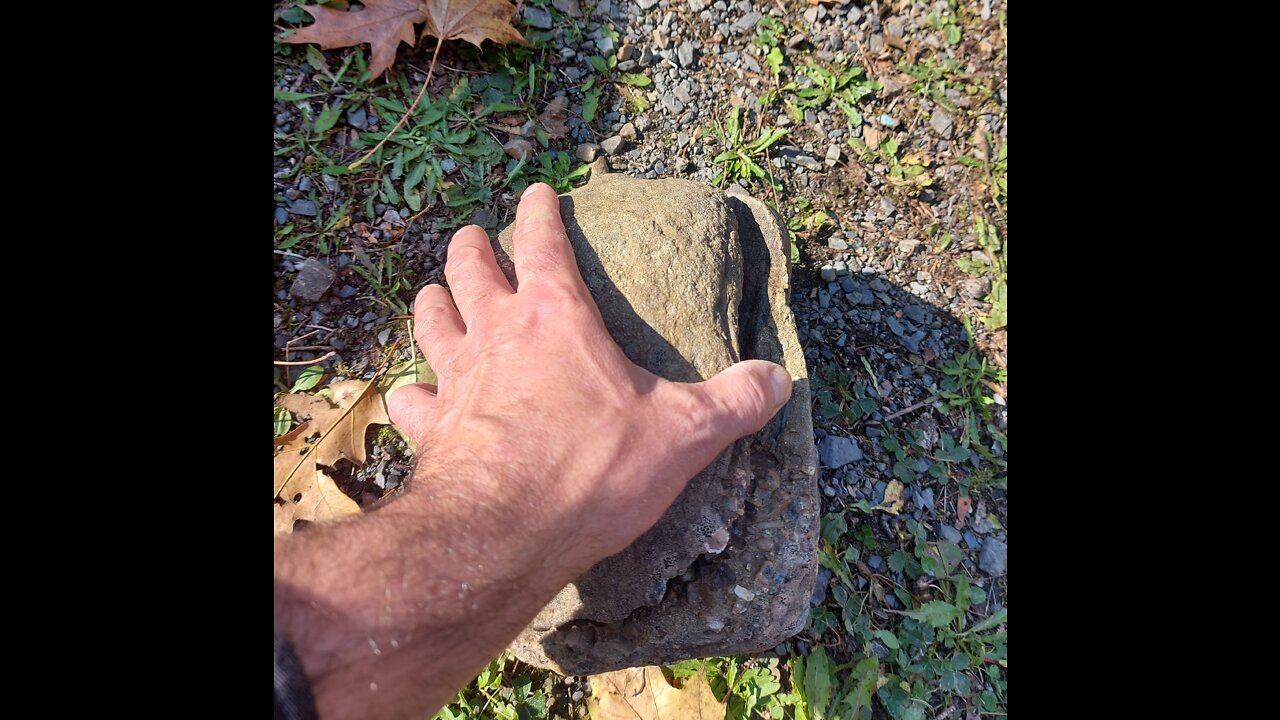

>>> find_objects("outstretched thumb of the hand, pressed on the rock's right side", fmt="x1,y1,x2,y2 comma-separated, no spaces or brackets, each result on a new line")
696,360,792,445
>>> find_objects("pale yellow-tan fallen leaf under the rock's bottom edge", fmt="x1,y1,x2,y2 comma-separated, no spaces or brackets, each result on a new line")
586,665,728,720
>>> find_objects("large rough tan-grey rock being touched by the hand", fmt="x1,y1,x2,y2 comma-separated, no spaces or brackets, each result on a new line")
495,160,820,675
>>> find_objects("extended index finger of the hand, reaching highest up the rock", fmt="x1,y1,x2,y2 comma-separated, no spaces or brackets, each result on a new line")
512,182,586,293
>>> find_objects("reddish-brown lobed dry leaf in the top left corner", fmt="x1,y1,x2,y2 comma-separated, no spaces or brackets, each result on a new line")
284,0,426,77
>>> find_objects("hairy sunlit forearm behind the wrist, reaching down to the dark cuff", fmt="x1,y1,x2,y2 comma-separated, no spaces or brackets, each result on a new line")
275,458,582,720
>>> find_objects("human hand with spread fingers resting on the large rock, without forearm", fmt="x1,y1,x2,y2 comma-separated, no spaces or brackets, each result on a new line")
388,183,791,578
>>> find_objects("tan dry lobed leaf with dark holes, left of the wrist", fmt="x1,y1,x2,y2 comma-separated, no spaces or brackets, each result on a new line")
275,380,390,534
